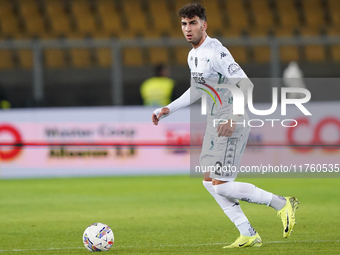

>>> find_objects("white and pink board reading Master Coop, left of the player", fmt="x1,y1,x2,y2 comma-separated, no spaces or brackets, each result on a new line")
0,107,190,178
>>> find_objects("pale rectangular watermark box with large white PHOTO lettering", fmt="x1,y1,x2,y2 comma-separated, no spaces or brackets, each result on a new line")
190,78,340,179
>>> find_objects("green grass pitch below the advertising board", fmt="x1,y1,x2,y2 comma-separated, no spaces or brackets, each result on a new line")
0,176,340,254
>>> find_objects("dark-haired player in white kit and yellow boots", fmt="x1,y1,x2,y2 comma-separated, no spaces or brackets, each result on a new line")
152,3,298,248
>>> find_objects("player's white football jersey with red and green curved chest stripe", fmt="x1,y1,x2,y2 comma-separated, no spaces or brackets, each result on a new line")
188,36,250,136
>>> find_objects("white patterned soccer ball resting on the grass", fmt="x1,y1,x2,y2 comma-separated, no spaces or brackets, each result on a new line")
83,223,114,251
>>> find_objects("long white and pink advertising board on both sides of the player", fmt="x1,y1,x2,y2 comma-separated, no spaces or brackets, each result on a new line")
0,102,340,178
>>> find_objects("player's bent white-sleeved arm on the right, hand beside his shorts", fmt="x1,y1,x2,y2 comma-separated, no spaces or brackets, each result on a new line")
212,46,254,137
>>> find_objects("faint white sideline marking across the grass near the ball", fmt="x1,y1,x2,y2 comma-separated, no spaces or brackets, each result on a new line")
0,240,340,252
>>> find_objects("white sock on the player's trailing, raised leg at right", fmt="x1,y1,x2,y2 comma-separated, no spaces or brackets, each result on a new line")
213,181,273,206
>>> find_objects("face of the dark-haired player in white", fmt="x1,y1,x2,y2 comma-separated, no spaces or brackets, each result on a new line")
181,16,207,48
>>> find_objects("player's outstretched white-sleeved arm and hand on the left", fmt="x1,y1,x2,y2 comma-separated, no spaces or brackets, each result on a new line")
151,87,201,125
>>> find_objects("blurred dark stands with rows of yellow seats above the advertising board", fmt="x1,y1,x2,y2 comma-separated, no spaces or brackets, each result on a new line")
0,0,340,108
